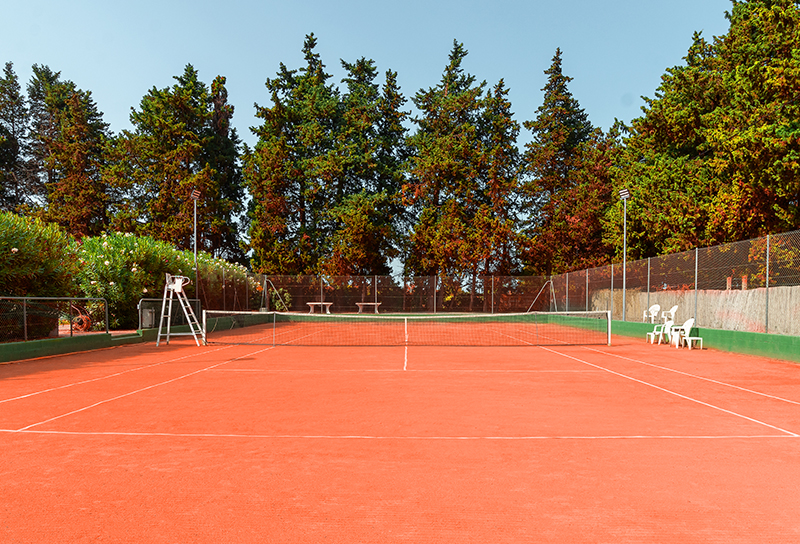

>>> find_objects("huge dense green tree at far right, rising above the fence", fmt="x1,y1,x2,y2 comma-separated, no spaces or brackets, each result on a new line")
620,0,800,257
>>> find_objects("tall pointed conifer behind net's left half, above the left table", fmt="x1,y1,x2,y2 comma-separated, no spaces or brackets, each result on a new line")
244,34,345,274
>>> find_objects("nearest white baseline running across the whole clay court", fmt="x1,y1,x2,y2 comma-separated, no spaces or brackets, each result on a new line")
0,429,800,442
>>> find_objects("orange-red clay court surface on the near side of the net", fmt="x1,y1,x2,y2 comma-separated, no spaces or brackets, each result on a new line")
0,337,800,543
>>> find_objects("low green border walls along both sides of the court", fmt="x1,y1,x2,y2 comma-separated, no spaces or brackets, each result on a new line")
0,321,800,363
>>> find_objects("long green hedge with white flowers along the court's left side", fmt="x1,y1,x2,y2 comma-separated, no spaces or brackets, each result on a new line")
0,218,263,329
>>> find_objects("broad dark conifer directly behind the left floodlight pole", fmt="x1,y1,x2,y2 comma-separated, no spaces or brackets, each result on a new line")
106,65,242,258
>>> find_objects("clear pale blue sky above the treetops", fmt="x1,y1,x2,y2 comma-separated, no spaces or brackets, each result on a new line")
0,0,731,145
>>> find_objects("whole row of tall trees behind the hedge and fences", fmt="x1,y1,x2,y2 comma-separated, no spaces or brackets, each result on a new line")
0,0,800,276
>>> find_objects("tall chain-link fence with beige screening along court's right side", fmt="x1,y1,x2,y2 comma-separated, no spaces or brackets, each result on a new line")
553,231,800,336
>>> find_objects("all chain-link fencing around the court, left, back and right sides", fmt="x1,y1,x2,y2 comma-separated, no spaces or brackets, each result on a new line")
0,227,780,342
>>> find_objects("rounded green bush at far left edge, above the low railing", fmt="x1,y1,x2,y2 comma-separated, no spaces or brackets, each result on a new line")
0,212,78,297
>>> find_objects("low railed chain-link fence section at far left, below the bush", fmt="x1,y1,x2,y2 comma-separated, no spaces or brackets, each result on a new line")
0,297,108,342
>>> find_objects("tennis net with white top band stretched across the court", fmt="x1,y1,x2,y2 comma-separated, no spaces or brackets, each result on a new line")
203,310,611,346
